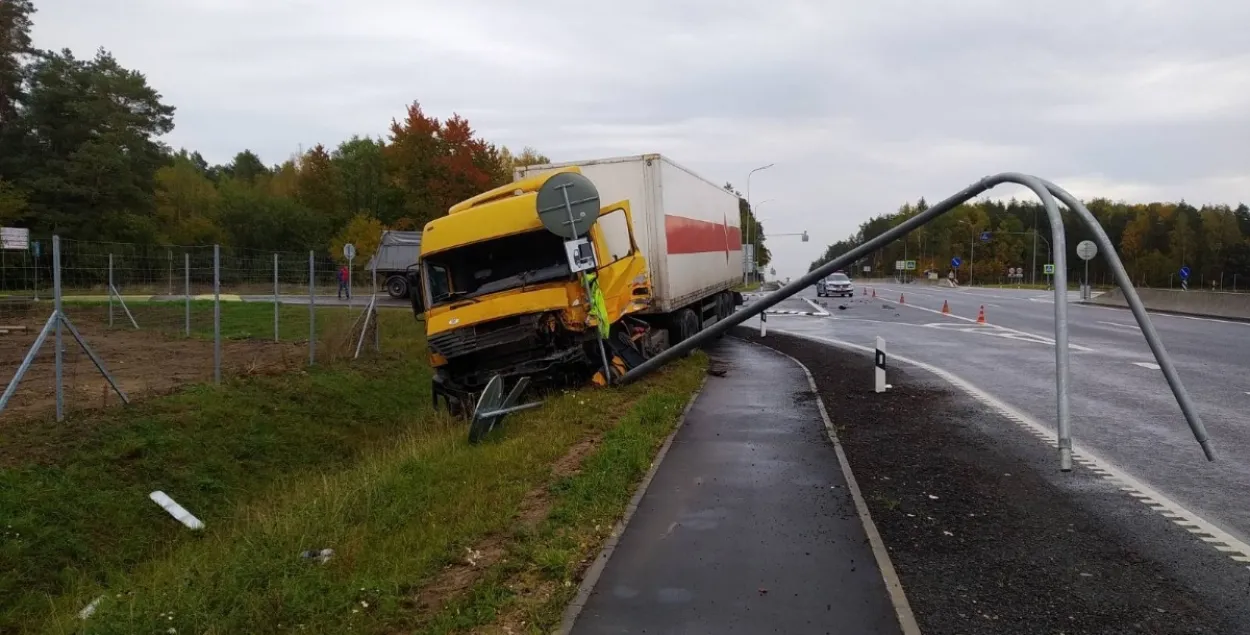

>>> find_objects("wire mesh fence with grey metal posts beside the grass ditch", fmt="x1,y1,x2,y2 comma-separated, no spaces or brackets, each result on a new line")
0,238,395,420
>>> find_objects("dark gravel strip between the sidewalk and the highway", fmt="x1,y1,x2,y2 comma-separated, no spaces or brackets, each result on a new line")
736,328,1250,635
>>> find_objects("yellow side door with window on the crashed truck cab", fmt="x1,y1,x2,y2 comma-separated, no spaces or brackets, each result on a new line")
591,201,650,323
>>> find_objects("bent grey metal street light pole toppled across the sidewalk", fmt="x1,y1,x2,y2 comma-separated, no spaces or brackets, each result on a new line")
620,173,1215,471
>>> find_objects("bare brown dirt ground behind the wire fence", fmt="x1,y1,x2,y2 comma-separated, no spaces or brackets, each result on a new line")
0,308,308,428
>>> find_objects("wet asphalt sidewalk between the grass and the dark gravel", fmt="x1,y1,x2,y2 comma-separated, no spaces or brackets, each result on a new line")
573,339,900,635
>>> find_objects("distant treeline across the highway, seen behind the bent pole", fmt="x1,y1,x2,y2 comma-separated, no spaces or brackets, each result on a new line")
811,199,1250,289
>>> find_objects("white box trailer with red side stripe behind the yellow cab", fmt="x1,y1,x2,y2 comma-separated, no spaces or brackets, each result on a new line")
514,154,743,313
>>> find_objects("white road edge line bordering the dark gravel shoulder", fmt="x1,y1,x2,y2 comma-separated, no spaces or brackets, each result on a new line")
778,329,1250,563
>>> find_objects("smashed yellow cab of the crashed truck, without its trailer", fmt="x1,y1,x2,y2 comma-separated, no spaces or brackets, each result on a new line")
409,166,666,411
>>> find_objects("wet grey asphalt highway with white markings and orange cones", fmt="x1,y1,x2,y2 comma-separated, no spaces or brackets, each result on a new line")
748,283,1250,555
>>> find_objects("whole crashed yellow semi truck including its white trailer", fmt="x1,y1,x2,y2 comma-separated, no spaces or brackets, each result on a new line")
408,154,743,413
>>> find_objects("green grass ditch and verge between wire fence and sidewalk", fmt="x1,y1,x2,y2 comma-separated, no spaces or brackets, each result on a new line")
0,303,705,634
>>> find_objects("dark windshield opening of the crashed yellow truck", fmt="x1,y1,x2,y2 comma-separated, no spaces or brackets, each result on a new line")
421,230,571,306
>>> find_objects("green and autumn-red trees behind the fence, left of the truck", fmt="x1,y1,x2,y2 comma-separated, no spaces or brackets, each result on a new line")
0,0,766,267
